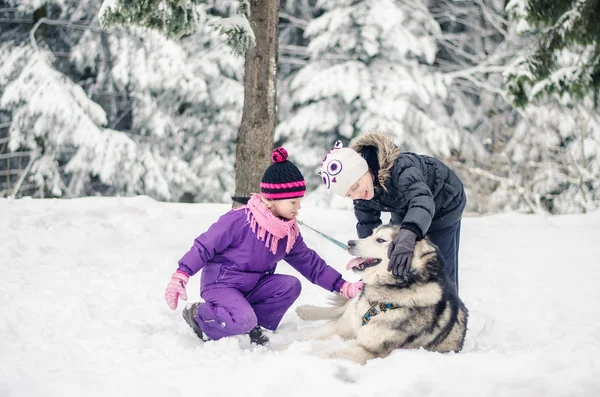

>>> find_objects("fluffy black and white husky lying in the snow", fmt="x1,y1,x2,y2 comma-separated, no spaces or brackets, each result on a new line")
296,225,468,364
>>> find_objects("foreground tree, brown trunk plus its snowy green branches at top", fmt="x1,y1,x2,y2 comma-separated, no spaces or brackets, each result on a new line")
100,0,279,201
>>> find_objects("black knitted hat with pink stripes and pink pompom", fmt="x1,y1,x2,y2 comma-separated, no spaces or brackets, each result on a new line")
260,147,306,200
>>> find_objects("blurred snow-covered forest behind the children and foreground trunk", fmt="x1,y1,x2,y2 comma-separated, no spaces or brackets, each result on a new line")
0,0,600,214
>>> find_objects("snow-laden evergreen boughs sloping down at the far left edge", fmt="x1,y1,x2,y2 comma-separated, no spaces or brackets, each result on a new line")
0,45,170,199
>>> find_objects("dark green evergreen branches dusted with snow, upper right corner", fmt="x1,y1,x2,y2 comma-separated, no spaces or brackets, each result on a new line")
506,0,600,106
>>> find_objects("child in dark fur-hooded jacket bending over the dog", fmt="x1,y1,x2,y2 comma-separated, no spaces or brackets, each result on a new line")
319,133,467,292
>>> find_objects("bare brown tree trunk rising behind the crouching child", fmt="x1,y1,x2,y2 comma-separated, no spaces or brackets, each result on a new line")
233,0,279,207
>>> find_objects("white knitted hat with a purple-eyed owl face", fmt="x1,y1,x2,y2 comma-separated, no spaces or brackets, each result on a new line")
319,141,369,197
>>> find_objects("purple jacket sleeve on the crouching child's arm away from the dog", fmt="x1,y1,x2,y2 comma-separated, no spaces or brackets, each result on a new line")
177,210,246,276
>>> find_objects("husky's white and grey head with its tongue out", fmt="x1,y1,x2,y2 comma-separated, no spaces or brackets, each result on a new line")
346,225,437,285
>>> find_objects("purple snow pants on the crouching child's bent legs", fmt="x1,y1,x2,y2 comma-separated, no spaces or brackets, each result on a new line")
195,274,302,340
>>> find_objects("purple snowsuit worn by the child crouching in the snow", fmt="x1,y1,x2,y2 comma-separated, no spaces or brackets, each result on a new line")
179,209,344,340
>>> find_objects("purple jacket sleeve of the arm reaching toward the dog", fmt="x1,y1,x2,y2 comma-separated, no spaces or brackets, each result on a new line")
283,236,344,292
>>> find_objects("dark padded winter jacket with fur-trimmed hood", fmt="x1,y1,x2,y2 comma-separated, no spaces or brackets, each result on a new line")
351,134,467,239
